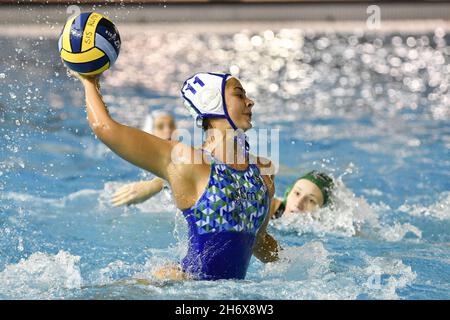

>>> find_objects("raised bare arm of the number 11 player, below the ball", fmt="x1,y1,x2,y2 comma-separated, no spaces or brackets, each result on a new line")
77,72,174,180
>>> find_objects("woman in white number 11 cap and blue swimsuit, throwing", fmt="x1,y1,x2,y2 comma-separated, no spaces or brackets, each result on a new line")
71,73,278,280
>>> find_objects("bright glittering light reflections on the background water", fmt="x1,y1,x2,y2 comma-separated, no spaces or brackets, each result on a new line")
107,29,450,121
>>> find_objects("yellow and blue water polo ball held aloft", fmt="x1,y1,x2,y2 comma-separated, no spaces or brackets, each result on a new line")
58,12,120,76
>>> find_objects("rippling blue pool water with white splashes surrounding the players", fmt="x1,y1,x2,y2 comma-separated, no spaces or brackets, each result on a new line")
0,27,450,299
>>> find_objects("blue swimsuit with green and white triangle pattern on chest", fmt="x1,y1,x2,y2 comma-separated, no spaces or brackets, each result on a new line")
182,151,269,280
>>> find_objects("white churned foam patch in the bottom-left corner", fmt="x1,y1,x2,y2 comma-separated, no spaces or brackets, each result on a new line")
0,250,83,299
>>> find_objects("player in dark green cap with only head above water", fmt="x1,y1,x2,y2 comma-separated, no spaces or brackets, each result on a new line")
270,171,334,219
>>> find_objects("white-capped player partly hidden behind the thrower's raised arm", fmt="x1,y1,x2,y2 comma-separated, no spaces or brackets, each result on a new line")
111,110,176,207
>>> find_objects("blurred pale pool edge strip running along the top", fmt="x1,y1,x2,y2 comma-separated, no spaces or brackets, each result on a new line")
0,2,450,37
